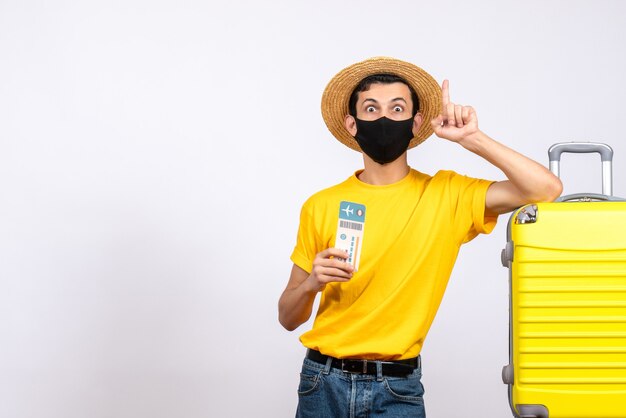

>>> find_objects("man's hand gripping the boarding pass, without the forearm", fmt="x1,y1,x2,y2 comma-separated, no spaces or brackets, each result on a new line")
307,248,354,292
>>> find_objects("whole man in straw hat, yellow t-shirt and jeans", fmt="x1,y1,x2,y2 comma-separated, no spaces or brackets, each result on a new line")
279,57,562,417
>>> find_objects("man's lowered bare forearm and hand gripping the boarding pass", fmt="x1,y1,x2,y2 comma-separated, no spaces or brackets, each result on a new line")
278,248,354,331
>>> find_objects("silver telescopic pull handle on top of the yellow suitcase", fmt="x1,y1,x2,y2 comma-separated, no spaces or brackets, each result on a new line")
548,142,613,196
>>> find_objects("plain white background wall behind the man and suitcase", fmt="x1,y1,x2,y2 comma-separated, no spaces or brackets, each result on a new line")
0,0,626,418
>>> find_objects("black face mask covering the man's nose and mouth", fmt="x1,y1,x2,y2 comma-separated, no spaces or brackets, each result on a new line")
354,116,413,164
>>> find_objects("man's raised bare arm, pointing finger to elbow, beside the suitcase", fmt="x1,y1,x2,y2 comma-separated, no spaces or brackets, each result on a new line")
431,80,563,215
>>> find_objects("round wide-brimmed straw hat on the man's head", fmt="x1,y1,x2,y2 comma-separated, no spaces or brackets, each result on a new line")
322,57,441,152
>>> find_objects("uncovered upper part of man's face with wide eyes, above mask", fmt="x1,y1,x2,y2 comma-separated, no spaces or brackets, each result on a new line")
346,83,422,136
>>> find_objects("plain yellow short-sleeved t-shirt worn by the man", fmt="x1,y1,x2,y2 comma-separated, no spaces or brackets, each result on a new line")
291,169,497,360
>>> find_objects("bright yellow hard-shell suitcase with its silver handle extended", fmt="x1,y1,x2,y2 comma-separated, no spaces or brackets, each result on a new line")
502,143,626,418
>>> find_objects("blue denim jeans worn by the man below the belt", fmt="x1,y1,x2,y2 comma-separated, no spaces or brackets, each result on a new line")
296,358,426,418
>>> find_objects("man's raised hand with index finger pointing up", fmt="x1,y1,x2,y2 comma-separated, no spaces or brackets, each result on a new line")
430,80,478,142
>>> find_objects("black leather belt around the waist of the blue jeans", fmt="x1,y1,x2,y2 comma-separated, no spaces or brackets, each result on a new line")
306,349,421,377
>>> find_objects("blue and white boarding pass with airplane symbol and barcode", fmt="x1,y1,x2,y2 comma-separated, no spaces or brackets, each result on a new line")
335,201,365,271
